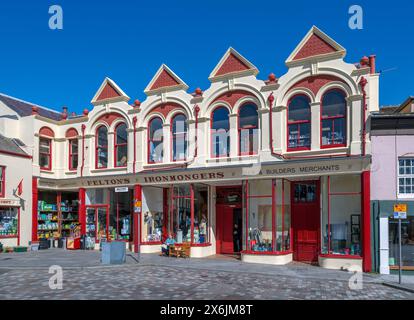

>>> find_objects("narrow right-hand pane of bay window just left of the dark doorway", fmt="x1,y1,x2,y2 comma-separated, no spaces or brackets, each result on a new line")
194,185,209,244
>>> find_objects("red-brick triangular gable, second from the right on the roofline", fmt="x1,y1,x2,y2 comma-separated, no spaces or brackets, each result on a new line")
209,47,259,80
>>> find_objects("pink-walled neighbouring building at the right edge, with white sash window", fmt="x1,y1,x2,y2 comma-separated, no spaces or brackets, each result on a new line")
371,97,414,274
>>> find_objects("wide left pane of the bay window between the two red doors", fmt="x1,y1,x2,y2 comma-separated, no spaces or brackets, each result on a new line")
248,180,273,252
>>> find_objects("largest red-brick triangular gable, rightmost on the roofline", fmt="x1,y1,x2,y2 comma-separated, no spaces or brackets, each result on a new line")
286,26,346,66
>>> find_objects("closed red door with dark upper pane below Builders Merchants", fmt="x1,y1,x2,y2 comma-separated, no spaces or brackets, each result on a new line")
291,181,320,263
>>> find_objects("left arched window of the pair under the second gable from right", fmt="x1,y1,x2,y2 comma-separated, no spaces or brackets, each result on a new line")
211,107,230,158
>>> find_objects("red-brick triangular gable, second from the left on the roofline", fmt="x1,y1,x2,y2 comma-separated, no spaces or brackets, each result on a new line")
144,64,188,94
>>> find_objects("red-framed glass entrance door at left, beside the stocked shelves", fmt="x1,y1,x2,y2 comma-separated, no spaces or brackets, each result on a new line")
86,205,110,243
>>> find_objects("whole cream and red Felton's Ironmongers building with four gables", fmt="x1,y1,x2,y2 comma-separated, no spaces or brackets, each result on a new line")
0,27,379,271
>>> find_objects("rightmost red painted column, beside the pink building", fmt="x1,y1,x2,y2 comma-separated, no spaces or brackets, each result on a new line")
361,171,372,272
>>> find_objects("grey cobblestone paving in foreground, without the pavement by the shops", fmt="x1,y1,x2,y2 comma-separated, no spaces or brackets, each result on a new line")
0,265,414,300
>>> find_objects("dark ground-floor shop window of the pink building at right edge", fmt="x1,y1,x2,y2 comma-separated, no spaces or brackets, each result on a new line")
388,216,414,267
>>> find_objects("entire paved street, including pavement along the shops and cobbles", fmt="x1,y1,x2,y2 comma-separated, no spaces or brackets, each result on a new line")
0,253,414,300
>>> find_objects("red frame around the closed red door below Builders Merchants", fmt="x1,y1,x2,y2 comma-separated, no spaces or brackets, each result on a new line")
290,179,321,261
